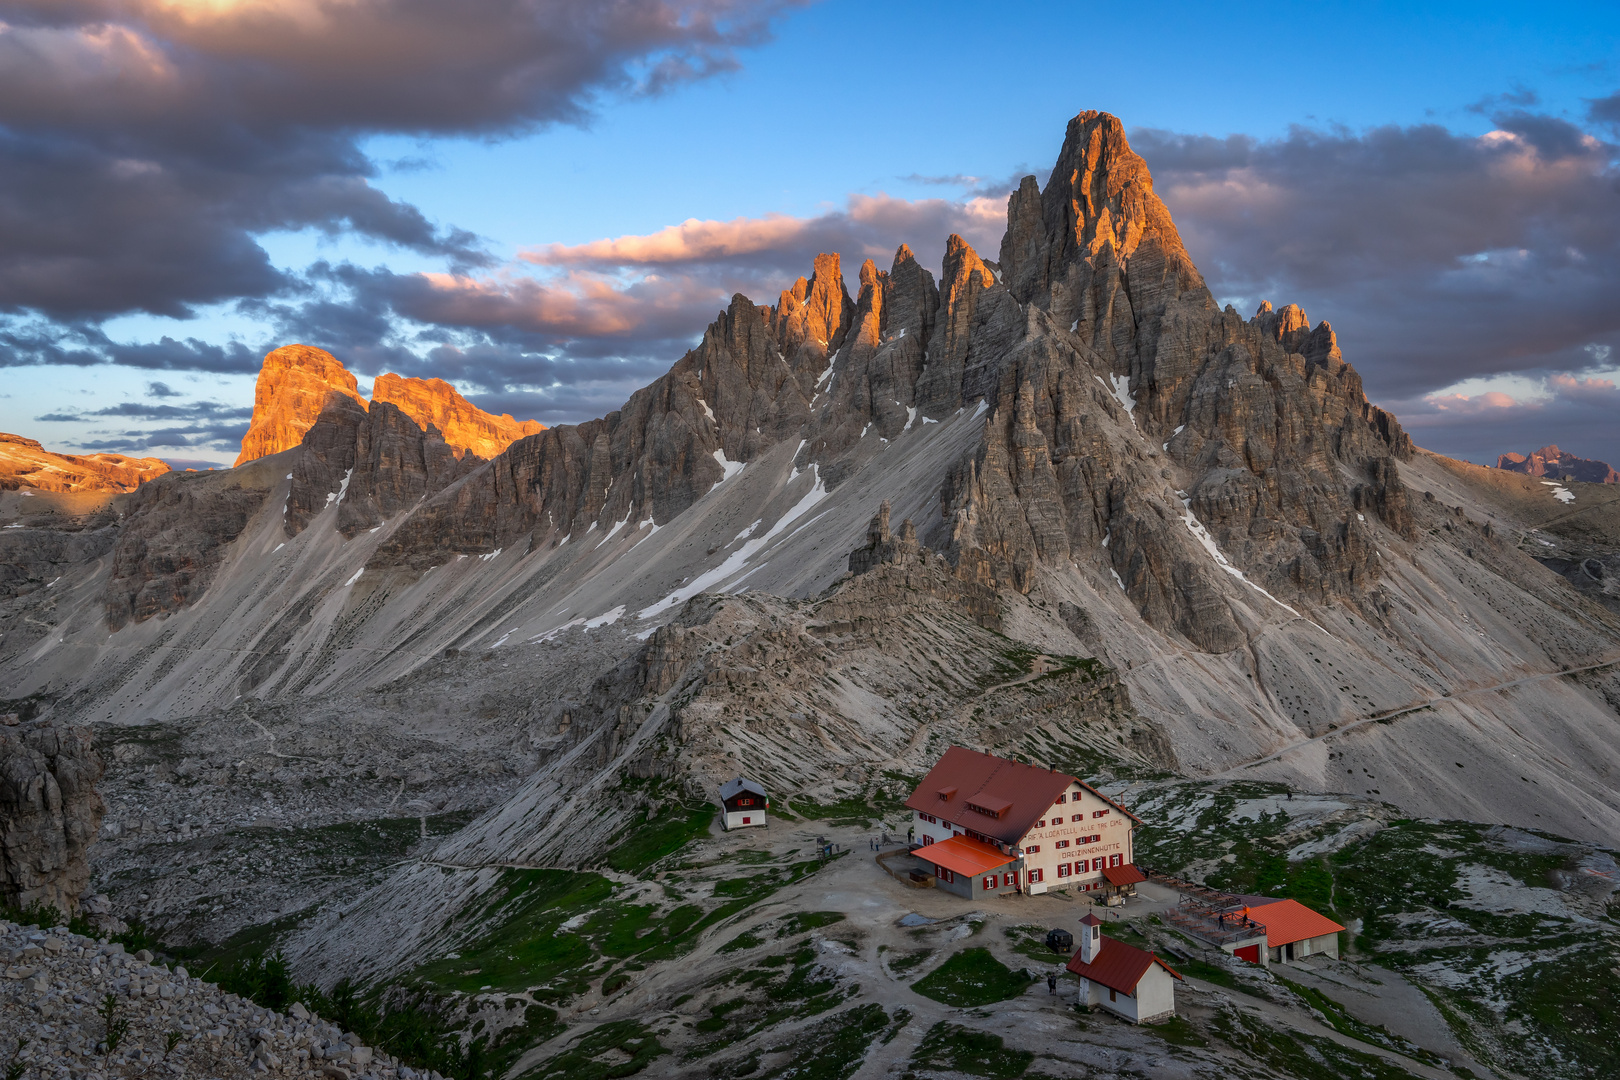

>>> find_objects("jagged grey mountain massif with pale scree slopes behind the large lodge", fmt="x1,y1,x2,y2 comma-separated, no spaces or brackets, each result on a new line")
0,113,1620,1016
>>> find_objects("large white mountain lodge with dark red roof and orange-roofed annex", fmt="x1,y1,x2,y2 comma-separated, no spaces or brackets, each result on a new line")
906,746,1144,899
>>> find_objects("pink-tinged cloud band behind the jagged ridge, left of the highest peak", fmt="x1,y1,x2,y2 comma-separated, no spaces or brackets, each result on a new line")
215,183,1006,423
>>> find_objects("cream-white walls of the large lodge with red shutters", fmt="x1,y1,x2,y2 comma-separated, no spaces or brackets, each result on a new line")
914,782,1134,894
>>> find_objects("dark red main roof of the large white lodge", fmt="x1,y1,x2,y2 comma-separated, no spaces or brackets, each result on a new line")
906,746,1142,844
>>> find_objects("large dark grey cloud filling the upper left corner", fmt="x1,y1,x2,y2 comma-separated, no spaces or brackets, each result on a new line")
0,0,803,323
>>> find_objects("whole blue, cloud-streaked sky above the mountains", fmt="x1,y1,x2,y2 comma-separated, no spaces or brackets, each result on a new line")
0,0,1620,463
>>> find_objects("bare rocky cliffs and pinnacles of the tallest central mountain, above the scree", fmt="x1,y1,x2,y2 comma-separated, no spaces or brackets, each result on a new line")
377,112,1413,653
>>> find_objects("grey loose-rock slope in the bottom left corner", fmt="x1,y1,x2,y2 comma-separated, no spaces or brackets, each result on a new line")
0,921,442,1080
